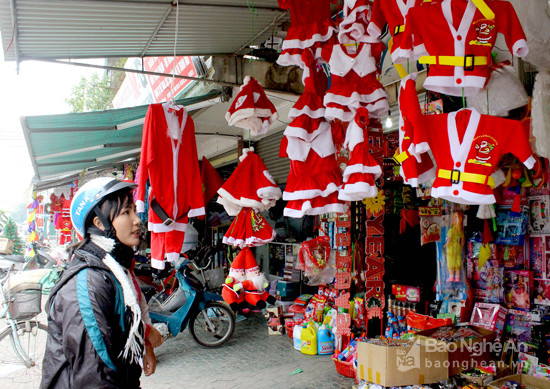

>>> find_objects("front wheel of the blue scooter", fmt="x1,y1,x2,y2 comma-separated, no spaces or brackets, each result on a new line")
189,301,235,348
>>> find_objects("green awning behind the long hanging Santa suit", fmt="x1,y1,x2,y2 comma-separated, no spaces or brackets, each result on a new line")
21,90,224,189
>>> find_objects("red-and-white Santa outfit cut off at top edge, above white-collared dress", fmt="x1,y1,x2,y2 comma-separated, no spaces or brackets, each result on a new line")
338,0,378,43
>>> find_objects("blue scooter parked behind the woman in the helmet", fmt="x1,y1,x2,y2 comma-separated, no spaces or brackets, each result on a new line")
149,258,235,348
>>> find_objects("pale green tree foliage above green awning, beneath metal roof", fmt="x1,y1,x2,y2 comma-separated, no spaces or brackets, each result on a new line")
65,58,126,112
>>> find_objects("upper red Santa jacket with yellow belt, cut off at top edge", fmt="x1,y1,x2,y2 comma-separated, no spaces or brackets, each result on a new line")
402,0,529,96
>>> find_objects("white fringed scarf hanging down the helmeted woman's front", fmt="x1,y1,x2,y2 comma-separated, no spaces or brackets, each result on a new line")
103,254,145,364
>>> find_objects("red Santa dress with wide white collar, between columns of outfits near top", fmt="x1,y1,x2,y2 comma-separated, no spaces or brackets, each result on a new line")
323,43,389,122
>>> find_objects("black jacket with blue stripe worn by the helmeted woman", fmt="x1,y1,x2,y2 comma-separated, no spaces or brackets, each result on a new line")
40,245,141,389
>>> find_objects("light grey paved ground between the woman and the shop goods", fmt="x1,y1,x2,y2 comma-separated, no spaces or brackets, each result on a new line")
141,313,355,389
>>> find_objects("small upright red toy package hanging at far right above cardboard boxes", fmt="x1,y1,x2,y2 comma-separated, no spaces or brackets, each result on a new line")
504,270,534,310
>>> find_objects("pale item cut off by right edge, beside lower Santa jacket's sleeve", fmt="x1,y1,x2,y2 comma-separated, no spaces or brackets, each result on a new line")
532,71,550,158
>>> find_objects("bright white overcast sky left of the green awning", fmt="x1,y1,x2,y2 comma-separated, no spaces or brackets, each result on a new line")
0,51,103,212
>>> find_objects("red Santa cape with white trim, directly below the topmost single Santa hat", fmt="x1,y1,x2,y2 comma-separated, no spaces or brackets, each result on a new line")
217,147,282,216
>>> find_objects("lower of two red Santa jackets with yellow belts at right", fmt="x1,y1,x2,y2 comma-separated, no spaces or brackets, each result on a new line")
413,109,535,204
